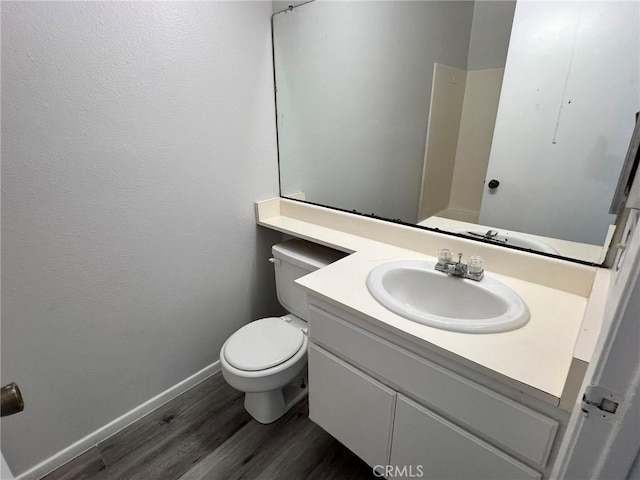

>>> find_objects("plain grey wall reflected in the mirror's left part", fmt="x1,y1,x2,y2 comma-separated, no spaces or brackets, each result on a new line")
274,1,473,222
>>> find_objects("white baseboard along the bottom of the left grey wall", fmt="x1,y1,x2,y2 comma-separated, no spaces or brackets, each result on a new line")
16,360,220,480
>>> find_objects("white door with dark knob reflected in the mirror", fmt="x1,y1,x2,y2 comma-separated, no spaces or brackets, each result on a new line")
480,1,640,245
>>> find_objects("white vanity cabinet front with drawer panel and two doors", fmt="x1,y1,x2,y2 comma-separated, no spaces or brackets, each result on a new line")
309,296,560,479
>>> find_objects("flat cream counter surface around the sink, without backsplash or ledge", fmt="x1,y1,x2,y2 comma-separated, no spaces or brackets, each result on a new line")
296,245,587,402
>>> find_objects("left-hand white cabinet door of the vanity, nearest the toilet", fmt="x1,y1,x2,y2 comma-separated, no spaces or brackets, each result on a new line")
309,344,396,467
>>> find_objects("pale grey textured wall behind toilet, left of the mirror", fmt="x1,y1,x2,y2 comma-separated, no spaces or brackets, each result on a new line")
2,2,280,474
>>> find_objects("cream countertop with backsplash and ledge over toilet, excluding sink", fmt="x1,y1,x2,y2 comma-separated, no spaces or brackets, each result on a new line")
256,198,611,411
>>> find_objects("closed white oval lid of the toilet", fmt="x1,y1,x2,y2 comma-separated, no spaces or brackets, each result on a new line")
224,317,304,371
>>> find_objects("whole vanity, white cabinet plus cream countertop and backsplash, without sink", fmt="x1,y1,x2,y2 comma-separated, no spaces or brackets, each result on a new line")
256,198,609,479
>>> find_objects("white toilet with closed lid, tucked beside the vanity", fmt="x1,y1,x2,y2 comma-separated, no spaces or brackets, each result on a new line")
220,239,345,423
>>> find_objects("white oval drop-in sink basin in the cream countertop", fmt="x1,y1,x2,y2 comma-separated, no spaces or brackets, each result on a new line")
367,260,529,333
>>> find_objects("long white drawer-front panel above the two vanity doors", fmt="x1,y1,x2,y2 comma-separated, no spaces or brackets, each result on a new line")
309,306,558,467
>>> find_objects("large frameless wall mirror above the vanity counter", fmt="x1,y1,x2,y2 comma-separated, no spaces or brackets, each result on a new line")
273,0,640,263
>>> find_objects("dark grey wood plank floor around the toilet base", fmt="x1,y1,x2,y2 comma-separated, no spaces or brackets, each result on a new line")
44,373,376,480
